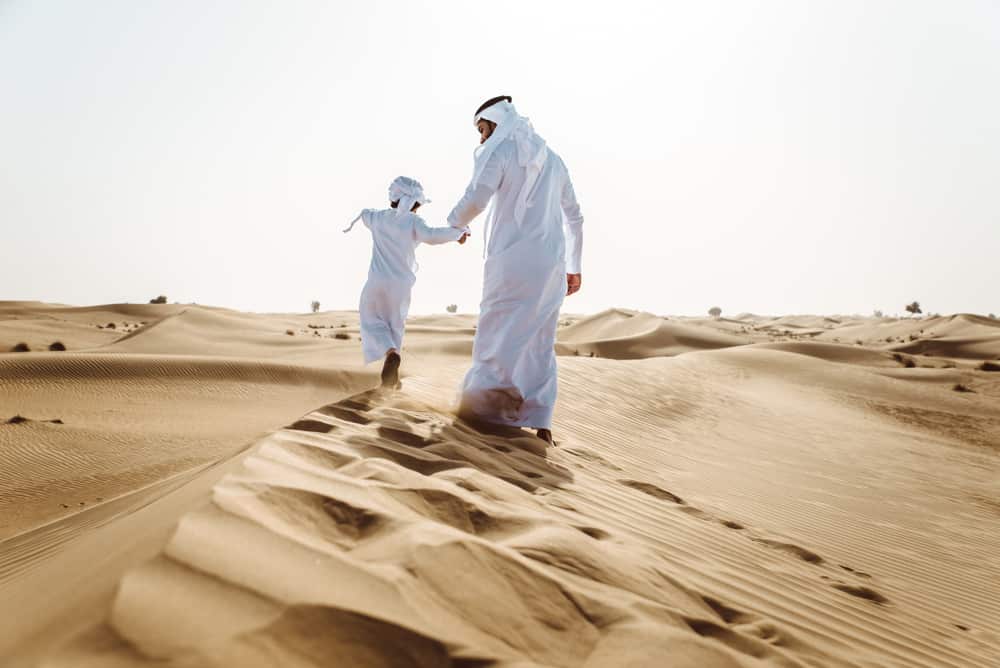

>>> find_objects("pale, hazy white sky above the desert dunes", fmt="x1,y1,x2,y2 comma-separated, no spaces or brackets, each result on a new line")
0,0,1000,314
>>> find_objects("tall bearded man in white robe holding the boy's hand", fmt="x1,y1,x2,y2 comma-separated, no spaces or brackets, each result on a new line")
448,95,583,444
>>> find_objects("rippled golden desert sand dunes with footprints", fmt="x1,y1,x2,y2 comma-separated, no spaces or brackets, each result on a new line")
0,302,1000,668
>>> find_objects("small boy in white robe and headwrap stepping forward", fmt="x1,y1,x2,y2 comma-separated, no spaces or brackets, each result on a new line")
344,176,469,388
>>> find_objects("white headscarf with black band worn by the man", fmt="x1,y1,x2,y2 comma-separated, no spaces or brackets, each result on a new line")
472,100,549,226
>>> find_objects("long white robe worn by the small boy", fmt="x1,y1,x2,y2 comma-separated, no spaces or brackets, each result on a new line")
358,209,465,364
